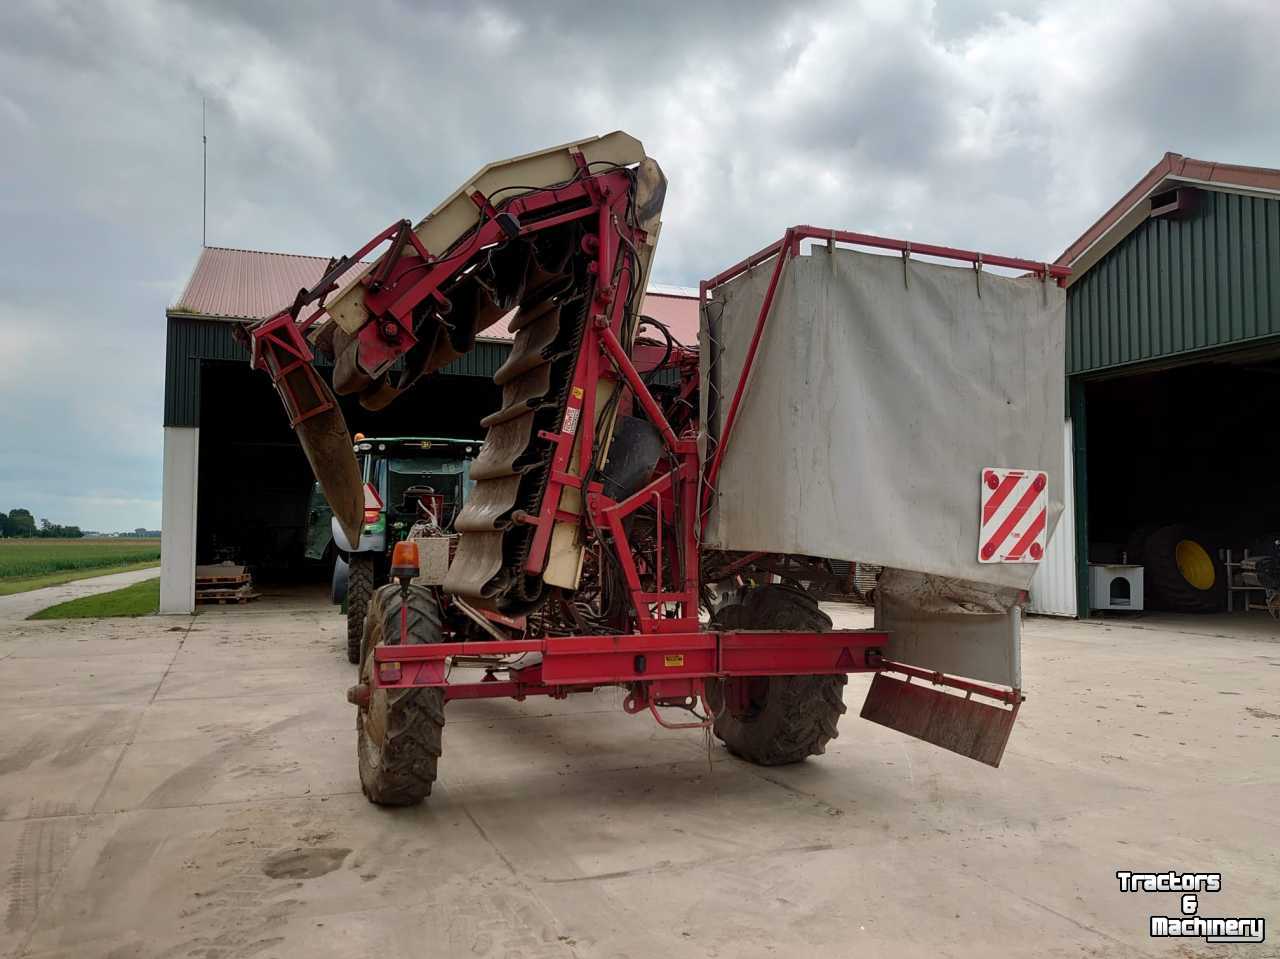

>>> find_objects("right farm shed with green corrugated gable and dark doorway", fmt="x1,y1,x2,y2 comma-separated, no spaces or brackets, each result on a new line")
1032,154,1280,615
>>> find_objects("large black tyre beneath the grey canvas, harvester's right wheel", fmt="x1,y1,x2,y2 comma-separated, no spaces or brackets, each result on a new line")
707,584,847,766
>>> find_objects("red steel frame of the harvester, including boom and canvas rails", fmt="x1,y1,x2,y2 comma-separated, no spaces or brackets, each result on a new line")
251,170,1049,726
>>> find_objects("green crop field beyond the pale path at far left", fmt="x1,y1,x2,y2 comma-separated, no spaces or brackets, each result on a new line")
0,539,160,595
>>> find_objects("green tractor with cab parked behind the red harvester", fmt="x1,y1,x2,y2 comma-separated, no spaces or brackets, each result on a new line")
306,433,481,663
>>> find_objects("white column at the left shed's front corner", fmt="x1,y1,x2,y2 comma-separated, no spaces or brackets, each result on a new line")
160,426,200,613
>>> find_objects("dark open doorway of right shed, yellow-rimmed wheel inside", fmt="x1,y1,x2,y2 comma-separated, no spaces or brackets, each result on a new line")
1085,346,1280,613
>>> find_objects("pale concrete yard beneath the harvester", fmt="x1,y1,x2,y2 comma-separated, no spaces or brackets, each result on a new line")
0,598,1280,959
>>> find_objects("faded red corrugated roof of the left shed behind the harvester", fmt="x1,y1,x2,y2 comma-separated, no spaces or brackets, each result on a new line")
169,246,698,346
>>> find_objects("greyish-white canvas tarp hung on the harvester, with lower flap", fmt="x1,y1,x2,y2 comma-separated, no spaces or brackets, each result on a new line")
701,247,1065,685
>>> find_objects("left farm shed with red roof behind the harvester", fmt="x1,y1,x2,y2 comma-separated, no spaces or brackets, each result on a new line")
160,247,698,613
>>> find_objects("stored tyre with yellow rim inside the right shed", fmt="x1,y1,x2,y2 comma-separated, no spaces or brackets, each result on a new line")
1142,524,1226,612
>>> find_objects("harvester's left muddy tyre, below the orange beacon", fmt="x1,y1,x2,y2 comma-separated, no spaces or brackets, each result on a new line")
356,584,444,805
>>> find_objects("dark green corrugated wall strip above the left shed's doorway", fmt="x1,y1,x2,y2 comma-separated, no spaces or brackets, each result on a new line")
164,316,511,426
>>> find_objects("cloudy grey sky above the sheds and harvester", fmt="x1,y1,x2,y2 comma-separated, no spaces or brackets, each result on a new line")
0,0,1280,530
